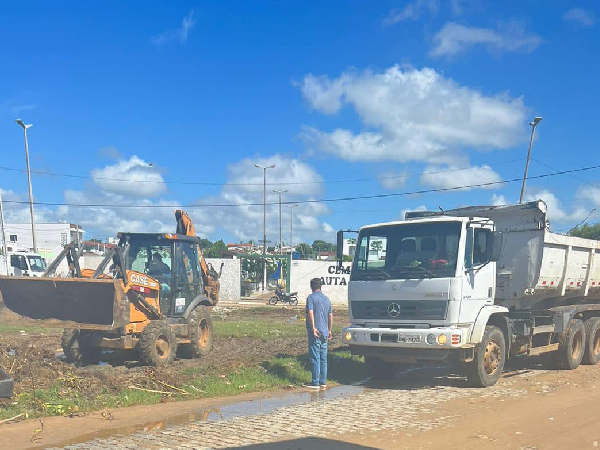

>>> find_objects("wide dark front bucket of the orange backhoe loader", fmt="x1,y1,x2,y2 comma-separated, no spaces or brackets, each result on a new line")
0,277,129,329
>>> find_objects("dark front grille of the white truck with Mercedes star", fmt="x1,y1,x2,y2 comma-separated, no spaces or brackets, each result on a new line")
350,300,448,320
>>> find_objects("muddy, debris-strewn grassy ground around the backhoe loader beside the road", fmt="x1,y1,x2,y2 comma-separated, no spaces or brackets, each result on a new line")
0,308,366,420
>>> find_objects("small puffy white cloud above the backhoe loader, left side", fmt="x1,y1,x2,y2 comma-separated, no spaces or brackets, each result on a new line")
91,156,166,198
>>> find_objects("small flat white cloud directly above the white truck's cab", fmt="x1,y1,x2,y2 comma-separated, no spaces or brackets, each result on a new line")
421,165,502,190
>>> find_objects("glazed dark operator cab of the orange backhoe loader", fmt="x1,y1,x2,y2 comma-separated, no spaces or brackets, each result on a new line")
119,233,204,316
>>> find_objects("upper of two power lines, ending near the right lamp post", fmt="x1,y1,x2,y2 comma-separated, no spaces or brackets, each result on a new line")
0,158,524,186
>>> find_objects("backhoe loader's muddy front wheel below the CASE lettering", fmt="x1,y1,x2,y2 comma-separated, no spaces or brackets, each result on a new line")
138,320,177,367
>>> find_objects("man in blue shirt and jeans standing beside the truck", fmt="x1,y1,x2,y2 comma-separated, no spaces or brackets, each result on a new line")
303,278,333,389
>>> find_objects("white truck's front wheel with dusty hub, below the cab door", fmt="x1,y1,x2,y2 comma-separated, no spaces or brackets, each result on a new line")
466,325,506,387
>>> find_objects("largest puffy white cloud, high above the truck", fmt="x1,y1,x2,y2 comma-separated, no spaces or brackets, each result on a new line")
301,65,527,164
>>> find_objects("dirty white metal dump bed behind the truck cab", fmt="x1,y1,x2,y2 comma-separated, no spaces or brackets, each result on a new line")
444,200,600,309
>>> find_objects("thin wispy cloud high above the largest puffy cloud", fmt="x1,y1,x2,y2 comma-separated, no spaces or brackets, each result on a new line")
429,22,542,57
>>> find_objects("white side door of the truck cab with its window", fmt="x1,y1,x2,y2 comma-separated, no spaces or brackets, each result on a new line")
460,224,496,321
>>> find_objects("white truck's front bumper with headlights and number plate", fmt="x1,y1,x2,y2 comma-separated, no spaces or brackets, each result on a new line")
342,325,470,350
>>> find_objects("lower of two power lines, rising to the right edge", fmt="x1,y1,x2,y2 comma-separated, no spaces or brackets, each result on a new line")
5,165,600,208
